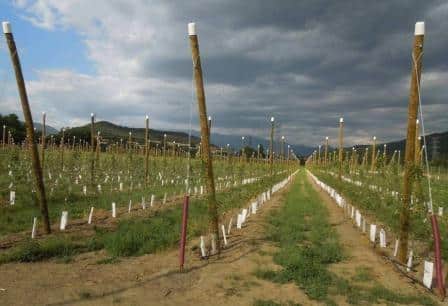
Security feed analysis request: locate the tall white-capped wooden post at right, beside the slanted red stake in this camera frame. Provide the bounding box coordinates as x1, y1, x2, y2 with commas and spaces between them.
398, 22, 425, 263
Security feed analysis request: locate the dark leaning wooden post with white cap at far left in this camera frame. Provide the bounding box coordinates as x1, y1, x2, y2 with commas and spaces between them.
2, 22, 51, 234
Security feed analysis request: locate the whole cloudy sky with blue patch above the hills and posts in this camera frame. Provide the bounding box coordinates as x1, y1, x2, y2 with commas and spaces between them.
0, 0, 448, 145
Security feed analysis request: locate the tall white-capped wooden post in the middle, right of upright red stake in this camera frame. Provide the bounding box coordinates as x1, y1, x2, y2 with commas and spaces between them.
188, 23, 221, 253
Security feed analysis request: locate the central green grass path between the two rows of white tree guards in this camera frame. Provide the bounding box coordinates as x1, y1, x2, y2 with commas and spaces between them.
255, 172, 435, 305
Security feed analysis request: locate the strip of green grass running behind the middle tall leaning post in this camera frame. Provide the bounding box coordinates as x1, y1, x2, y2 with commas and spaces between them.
0, 171, 286, 263
